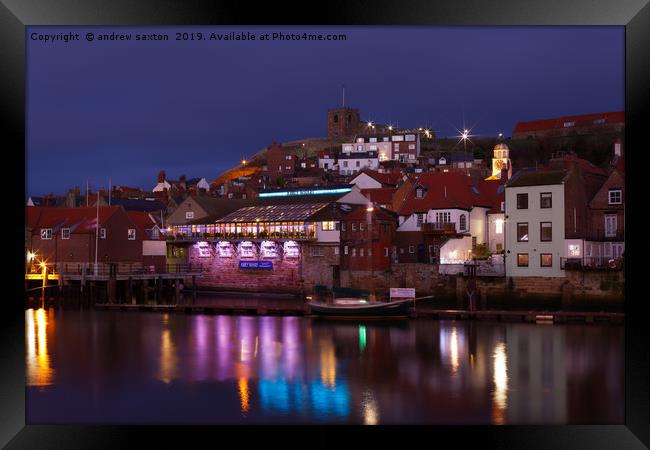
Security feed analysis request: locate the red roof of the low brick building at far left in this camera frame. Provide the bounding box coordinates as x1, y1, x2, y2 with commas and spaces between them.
25, 206, 121, 233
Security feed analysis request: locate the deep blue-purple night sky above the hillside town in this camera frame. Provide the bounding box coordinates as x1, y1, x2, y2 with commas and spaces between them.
26, 26, 624, 195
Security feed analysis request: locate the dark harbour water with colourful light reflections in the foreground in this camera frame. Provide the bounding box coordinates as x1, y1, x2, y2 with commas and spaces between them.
25, 308, 625, 425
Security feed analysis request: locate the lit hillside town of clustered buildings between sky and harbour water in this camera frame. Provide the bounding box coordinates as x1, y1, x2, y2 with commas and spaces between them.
25, 107, 625, 306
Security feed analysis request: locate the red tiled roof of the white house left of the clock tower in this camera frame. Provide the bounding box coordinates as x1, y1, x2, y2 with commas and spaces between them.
399, 172, 500, 216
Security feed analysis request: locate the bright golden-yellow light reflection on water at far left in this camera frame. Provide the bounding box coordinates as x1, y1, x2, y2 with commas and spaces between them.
25, 308, 54, 386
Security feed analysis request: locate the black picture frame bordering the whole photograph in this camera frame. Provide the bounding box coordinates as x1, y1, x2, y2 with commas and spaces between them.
0, 0, 650, 449
